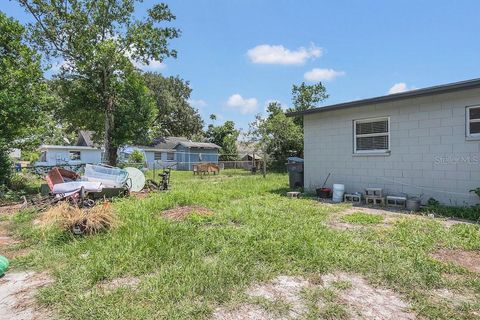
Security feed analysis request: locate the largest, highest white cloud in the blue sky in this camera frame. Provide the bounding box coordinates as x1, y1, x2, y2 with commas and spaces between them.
247, 44, 322, 64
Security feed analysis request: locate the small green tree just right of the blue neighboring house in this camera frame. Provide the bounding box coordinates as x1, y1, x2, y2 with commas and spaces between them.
205, 121, 240, 161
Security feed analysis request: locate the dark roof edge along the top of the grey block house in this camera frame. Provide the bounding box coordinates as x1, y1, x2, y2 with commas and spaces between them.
287, 78, 480, 117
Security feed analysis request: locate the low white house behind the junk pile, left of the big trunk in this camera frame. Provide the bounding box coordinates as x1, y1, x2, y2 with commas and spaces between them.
35, 145, 102, 166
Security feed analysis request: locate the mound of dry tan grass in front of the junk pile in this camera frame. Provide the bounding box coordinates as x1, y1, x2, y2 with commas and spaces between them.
41, 202, 118, 234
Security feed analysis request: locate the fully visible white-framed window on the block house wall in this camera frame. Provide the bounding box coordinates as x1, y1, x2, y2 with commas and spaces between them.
353, 117, 390, 153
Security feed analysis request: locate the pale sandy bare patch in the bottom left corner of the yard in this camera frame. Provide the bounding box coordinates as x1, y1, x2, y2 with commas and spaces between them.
0, 272, 53, 320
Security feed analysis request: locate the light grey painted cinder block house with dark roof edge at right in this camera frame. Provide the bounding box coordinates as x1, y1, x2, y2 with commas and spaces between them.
288, 79, 480, 205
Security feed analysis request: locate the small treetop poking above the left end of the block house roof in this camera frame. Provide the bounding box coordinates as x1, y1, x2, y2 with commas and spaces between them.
287, 82, 328, 128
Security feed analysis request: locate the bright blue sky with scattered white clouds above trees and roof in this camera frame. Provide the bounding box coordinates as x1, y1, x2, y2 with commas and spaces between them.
0, 0, 480, 129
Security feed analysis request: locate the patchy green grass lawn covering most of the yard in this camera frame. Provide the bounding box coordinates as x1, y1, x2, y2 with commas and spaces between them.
6, 172, 480, 319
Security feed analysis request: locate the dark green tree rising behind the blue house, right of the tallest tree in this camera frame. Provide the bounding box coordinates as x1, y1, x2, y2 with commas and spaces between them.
143, 72, 203, 138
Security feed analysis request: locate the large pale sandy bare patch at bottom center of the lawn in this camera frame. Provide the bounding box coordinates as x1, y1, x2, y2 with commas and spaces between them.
213, 272, 416, 320
